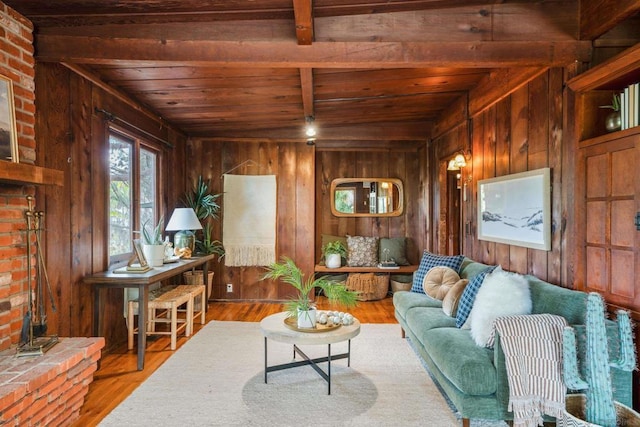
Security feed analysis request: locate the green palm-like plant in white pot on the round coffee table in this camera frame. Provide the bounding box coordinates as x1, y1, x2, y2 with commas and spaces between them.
262, 257, 358, 328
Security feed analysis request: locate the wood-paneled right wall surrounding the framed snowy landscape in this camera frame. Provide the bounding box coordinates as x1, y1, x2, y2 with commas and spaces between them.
429, 69, 575, 287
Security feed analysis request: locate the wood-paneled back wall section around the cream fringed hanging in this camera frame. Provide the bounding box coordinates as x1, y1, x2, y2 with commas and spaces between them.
186, 139, 315, 300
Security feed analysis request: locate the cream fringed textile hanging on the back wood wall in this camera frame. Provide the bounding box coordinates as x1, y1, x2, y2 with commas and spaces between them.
222, 174, 277, 267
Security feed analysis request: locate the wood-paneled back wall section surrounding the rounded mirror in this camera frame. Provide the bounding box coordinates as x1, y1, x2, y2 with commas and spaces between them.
315, 150, 426, 263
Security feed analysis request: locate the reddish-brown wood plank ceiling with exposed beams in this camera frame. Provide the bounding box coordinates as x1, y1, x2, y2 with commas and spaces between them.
3, 0, 639, 145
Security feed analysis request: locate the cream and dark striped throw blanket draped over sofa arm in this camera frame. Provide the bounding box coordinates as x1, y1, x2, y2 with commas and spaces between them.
489, 314, 567, 427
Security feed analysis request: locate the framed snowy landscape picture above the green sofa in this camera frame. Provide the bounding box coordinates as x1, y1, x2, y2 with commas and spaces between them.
478, 168, 551, 251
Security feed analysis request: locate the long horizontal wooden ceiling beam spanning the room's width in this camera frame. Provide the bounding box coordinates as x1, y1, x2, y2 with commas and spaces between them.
36, 35, 591, 68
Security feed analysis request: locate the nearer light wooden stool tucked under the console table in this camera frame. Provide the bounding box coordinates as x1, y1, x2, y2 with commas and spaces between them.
127, 287, 194, 350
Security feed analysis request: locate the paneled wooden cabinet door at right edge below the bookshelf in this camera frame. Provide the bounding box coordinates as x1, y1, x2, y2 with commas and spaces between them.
577, 139, 640, 311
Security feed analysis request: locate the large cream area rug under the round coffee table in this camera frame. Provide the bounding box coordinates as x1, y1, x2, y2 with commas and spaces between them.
100, 321, 504, 427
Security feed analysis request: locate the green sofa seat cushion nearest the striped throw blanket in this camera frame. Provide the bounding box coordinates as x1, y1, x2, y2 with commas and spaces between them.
417, 326, 497, 396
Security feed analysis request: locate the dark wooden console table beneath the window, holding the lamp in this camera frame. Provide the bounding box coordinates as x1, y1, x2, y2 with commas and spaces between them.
83, 254, 215, 371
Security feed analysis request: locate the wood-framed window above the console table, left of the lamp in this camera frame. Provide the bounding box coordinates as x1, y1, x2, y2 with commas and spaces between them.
109, 129, 160, 263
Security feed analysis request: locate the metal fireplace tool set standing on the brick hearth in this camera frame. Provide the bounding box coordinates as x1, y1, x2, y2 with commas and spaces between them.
18, 196, 58, 356
